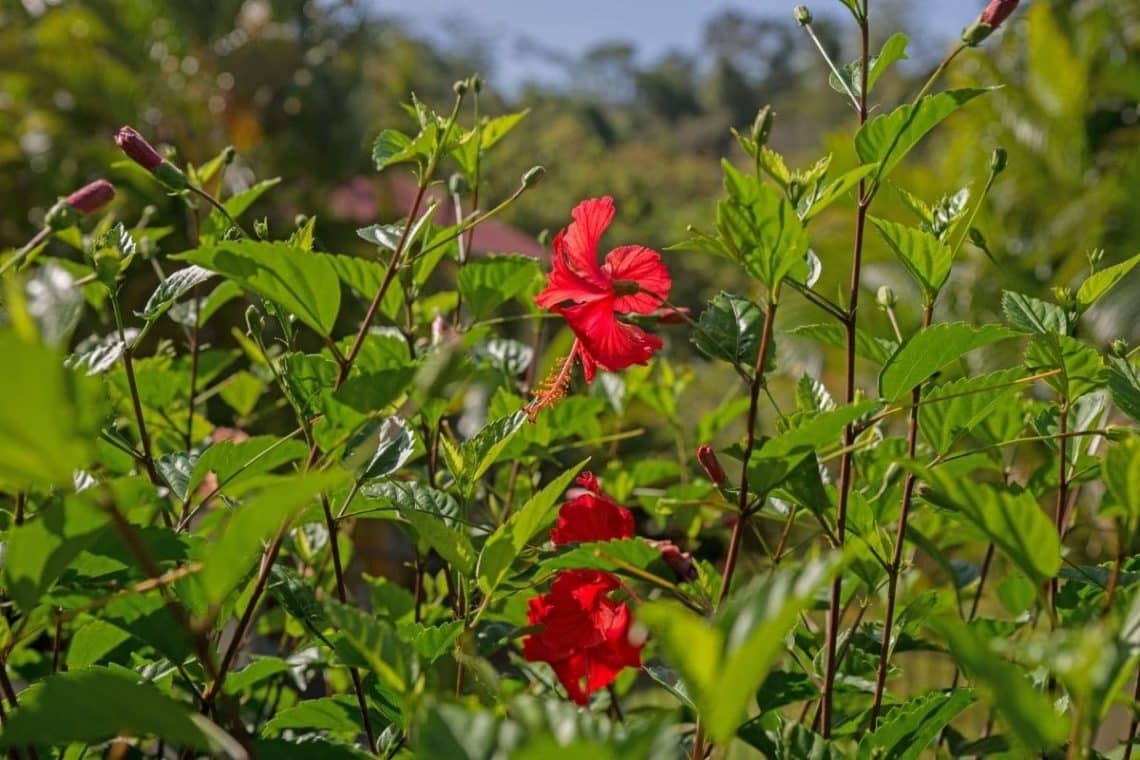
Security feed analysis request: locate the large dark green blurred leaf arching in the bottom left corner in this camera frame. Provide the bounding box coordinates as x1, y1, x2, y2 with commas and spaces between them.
0, 668, 218, 750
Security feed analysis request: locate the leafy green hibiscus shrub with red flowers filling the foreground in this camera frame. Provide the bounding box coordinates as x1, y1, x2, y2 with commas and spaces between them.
0, 0, 1140, 760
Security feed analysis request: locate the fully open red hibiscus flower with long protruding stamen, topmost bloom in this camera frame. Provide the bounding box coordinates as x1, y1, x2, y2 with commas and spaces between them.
530, 196, 673, 418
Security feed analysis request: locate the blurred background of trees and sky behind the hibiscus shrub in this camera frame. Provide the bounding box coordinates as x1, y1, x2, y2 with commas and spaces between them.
0, 0, 1140, 342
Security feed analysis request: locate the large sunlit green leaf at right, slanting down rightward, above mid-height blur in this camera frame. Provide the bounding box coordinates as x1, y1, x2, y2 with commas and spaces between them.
904, 463, 1061, 588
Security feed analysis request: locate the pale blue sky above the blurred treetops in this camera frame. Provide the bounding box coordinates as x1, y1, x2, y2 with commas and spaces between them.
372, 0, 983, 89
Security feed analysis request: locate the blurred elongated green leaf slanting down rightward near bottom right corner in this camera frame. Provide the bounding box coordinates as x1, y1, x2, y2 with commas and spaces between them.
931, 619, 1069, 753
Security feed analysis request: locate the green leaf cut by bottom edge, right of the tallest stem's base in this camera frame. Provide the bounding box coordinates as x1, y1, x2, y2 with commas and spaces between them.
858, 688, 974, 760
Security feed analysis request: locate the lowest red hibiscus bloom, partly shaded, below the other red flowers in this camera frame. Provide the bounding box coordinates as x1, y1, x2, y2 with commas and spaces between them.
522, 570, 641, 704
